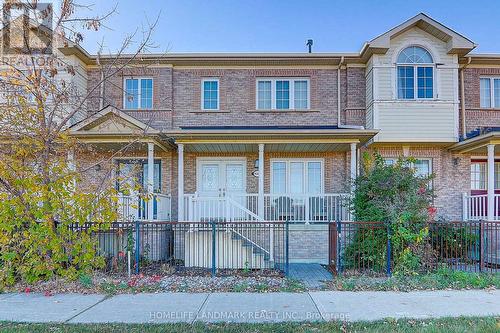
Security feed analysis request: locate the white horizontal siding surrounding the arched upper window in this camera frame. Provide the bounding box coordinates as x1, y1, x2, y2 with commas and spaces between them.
367, 28, 458, 142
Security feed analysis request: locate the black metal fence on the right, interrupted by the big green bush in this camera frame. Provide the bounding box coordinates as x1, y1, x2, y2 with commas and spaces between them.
329, 221, 500, 275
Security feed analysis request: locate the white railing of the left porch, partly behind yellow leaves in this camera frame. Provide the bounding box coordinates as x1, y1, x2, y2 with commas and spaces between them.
118, 193, 172, 221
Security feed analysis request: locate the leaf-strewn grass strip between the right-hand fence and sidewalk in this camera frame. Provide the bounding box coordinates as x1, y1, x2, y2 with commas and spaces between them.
328, 268, 500, 291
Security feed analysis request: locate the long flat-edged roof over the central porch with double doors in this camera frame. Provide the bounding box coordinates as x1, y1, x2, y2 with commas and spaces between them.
168, 126, 378, 153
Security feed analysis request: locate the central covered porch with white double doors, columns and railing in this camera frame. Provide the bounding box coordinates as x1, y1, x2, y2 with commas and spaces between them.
173, 126, 376, 224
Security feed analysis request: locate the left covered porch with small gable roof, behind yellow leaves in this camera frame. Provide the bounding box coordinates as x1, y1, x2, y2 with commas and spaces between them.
68, 106, 175, 222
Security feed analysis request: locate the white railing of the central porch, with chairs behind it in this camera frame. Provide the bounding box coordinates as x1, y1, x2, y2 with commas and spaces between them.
184, 193, 351, 223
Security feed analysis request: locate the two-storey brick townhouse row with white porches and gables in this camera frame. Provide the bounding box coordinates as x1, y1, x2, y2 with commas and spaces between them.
62, 14, 500, 261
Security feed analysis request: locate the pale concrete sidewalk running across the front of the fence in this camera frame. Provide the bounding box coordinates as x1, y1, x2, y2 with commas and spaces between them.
0, 290, 500, 323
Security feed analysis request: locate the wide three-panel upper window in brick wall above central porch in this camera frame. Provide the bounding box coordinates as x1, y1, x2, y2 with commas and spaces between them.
256, 78, 310, 110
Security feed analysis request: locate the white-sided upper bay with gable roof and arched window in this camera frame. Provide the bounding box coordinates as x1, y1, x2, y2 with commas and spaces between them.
361, 13, 476, 143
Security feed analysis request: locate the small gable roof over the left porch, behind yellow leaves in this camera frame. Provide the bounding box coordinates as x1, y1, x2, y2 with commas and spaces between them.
70, 105, 160, 136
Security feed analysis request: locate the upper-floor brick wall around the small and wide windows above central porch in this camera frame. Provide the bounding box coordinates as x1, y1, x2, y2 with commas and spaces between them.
173, 69, 337, 128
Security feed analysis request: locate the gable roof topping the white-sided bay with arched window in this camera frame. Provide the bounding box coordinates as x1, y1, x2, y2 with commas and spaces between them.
361, 13, 477, 56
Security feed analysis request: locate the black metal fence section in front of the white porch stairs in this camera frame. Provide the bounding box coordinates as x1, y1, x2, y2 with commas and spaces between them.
72, 221, 288, 275
